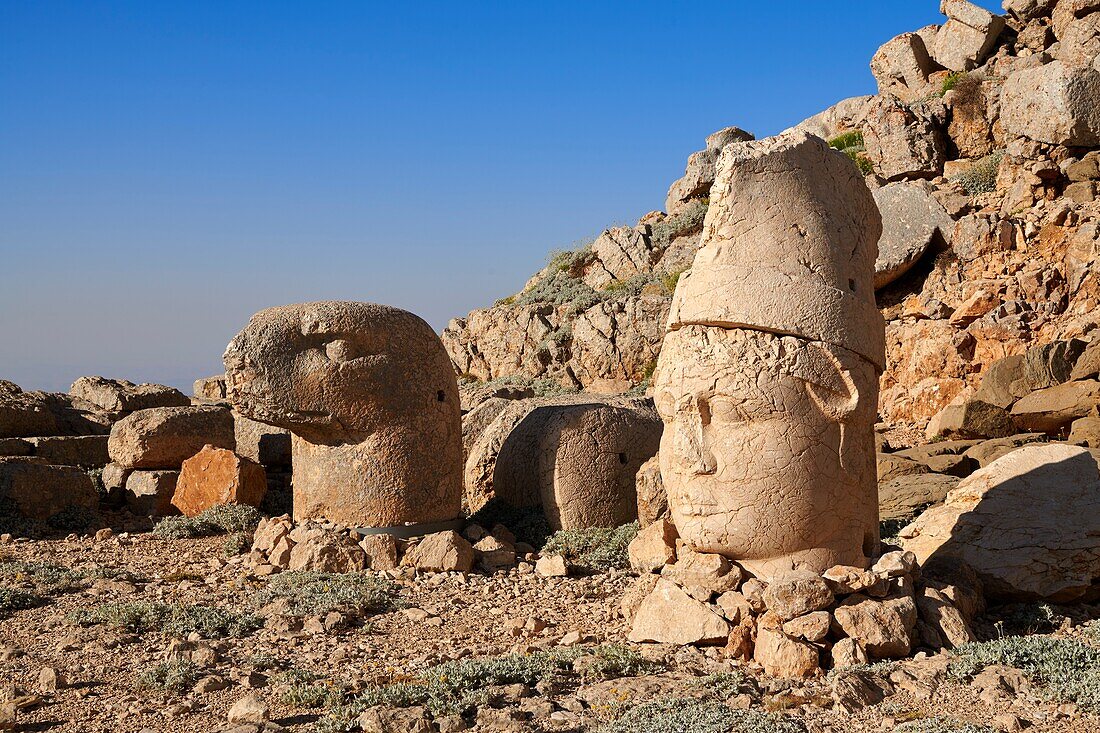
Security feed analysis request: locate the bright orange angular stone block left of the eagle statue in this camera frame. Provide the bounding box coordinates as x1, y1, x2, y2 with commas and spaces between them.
172, 446, 267, 516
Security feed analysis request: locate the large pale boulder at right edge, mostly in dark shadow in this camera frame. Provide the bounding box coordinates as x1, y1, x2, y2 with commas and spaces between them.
902, 444, 1100, 602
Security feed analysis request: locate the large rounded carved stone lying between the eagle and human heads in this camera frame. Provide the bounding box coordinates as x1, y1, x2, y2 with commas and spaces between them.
459, 395, 661, 528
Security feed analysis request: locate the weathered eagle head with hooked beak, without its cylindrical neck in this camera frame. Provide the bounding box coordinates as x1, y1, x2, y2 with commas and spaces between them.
224, 302, 459, 442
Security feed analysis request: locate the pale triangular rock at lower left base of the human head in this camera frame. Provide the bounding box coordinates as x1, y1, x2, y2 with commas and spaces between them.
627, 578, 730, 645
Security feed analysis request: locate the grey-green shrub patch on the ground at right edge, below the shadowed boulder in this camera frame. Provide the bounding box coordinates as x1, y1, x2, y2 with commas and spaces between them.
949, 636, 1100, 711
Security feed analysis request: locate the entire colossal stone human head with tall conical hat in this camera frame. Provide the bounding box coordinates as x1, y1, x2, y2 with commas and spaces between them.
653, 133, 884, 579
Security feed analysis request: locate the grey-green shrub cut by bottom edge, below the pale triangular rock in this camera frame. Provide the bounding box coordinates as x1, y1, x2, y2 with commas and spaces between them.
597, 698, 806, 733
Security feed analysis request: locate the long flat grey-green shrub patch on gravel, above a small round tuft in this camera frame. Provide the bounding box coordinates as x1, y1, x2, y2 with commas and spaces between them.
69, 601, 263, 638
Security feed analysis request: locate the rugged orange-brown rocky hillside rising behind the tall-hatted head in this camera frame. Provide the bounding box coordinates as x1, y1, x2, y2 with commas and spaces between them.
442, 0, 1100, 427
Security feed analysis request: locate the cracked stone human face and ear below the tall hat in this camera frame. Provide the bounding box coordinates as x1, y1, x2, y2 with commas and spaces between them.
653, 326, 878, 578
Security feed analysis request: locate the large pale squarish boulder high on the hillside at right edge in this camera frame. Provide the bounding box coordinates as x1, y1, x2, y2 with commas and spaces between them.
1000, 62, 1100, 147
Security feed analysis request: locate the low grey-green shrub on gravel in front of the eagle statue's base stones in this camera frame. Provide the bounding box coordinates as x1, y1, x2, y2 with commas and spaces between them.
255, 570, 398, 616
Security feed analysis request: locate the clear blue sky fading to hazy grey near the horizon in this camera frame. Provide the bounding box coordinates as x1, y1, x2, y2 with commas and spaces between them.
0, 0, 998, 390
